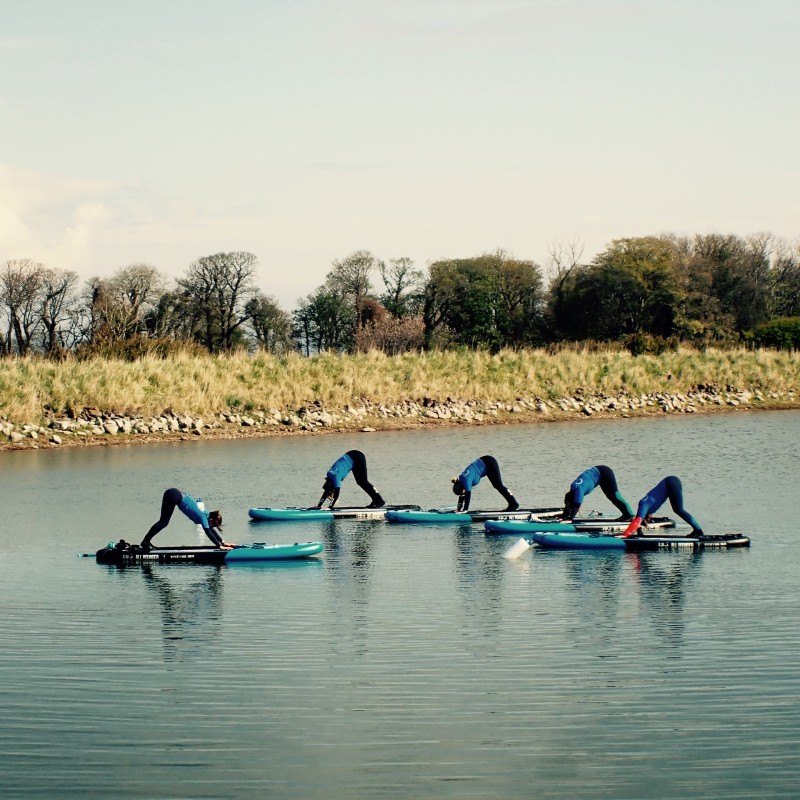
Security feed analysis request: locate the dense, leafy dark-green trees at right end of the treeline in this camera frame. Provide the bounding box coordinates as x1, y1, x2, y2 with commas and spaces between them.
548, 234, 800, 342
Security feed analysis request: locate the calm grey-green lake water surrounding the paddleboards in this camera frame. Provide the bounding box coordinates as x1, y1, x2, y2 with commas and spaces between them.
0, 412, 800, 800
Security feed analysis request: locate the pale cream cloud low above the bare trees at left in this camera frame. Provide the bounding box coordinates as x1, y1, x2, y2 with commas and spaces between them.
0, 164, 276, 278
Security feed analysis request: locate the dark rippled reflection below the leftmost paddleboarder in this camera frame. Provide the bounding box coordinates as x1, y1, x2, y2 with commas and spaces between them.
139, 564, 223, 663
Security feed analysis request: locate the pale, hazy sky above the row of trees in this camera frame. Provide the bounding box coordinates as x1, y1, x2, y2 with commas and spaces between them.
0, 0, 800, 309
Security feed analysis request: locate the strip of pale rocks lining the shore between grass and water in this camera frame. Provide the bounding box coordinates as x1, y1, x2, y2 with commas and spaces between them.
0, 386, 800, 450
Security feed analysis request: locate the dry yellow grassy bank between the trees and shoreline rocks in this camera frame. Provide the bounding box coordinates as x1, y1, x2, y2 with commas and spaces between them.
0, 350, 800, 422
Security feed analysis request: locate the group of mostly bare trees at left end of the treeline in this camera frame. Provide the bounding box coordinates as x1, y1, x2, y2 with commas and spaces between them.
0, 252, 294, 357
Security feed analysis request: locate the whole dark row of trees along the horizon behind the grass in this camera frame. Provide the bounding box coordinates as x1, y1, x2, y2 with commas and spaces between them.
0, 234, 800, 358
